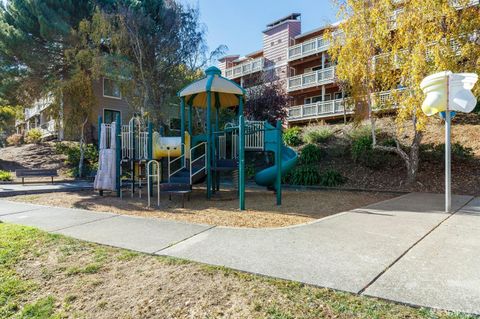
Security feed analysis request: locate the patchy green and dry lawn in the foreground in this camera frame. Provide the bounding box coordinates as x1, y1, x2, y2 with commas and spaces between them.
0, 223, 474, 319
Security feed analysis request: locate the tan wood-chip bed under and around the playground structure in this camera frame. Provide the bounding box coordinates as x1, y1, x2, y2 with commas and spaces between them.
10, 189, 395, 228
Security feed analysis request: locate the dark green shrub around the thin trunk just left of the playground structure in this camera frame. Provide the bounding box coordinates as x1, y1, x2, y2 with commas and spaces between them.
55, 143, 98, 176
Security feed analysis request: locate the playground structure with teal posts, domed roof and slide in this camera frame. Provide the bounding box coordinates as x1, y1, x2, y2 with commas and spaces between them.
93, 67, 298, 210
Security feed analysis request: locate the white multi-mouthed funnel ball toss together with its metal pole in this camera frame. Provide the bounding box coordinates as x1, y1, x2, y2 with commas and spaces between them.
420, 71, 478, 213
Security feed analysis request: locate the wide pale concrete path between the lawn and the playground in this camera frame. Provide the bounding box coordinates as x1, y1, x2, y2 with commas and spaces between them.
0, 193, 480, 314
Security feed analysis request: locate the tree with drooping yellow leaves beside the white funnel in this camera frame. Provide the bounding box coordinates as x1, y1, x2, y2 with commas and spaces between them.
330, 0, 480, 183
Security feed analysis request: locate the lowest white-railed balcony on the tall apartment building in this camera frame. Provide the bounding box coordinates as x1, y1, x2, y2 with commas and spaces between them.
288, 99, 353, 122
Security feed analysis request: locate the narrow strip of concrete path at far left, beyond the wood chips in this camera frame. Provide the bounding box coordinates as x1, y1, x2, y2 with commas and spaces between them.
0, 181, 93, 197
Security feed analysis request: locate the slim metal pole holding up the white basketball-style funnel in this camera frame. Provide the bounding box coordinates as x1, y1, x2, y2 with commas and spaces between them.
445, 75, 452, 213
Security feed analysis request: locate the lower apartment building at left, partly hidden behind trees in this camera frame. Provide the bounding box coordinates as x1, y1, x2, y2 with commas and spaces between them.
15, 78, 132, 140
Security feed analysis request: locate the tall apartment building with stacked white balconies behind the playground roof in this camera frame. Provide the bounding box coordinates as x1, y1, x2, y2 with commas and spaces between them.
219, 13, 351, 124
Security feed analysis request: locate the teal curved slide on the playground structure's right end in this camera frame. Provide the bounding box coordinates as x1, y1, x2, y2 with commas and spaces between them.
255, 124, 298, 187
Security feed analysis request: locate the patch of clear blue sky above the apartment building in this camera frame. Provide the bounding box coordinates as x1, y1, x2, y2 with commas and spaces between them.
181, 0, 337, 55
